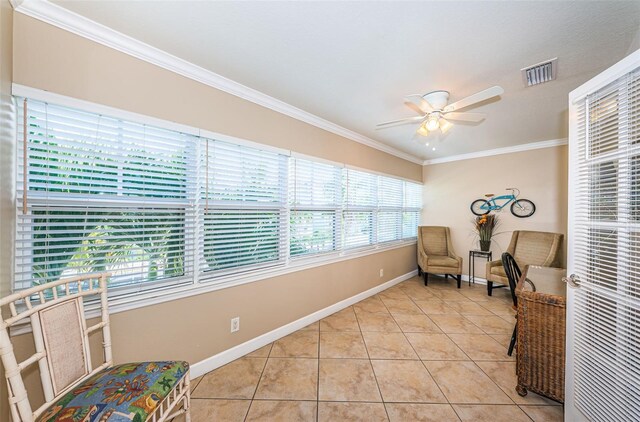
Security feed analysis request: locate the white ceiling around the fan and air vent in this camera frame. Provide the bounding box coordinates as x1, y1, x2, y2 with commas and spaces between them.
55, 0, 640, 159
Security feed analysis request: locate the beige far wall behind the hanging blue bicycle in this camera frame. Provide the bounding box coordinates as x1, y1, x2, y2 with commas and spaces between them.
422, 146, 568, 278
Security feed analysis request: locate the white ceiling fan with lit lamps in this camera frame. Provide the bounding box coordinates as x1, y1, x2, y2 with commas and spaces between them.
376, 86, 504, 136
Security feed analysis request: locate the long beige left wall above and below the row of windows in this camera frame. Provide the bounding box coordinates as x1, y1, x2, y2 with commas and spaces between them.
0, 9, 422, 421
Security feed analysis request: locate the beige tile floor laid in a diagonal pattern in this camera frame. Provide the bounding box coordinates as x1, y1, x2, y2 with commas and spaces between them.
179, 277, 563, 422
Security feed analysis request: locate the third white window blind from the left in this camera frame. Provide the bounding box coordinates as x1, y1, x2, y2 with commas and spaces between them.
289, 158, 342, 257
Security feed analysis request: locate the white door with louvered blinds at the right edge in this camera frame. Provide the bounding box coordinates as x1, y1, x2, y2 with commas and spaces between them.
565, 50, 640, 422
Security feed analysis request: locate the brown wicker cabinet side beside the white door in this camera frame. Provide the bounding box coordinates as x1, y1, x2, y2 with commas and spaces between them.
516, 271, 567, 403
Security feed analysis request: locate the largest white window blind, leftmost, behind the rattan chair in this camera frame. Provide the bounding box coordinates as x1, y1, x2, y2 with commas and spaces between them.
15, 99, 195, 289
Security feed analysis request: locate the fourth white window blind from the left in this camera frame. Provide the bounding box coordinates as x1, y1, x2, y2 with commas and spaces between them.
342, 169, 378, 249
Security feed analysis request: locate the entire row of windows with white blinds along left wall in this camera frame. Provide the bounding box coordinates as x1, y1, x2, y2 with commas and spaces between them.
14, 95, 421, 295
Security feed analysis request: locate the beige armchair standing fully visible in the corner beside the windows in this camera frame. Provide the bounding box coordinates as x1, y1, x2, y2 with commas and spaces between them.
418, 226, 462, 288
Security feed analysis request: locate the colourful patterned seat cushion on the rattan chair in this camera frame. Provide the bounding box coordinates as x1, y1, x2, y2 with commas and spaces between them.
38, 361, 189, 422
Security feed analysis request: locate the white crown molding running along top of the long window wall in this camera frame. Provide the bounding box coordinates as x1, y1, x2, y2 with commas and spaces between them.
11, 0, 422, 164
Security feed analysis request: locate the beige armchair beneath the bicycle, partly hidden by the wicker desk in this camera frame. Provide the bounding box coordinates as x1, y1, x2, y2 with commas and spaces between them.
486, 230, 564, 296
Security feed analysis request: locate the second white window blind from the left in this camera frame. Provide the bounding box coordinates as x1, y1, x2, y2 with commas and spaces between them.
200, 139, 287, 275
